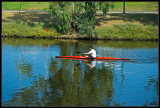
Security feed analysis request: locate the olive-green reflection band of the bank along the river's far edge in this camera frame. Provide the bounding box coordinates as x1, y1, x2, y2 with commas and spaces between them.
2, 38, 158, 50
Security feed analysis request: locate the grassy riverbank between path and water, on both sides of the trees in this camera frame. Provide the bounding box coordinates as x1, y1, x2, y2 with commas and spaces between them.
2, 12, 158, 41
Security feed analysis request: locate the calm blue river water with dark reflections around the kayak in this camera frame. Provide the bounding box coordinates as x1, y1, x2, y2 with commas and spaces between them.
2, 39, 159, 106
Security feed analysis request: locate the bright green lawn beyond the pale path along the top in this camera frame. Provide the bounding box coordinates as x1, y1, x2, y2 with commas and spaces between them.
2, 2, 158, 11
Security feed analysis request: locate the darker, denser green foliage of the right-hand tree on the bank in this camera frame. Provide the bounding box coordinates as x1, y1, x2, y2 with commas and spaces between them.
73, 2, 96, 36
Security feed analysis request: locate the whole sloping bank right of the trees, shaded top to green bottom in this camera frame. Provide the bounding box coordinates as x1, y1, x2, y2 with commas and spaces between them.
96, 14, 158, 40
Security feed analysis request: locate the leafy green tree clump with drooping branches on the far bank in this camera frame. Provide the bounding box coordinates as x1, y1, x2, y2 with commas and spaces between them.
49, 2, 114, 36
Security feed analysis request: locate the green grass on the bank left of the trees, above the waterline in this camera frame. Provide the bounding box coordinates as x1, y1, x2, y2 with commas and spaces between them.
2, 21, 60, 37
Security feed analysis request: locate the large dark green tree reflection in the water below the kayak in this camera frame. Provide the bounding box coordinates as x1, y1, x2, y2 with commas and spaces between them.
5, 57, 114, 106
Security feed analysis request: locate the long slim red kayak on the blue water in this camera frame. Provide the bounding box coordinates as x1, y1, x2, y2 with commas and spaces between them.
55, 56, 130, 60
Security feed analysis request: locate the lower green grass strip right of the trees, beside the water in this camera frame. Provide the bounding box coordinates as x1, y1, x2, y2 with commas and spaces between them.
96, 23, 158, 39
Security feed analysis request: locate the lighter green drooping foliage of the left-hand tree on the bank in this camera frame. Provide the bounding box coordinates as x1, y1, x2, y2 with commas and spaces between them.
49, 2, 72, 34
